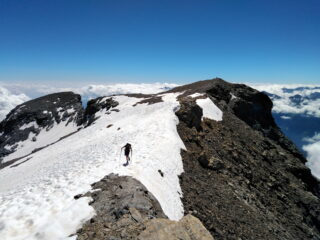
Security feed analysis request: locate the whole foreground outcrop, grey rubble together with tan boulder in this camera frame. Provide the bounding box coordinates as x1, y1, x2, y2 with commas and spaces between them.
77, 174, 212, 240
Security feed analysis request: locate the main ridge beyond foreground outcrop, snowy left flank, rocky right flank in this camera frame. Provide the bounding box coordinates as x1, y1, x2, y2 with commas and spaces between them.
0, 79, 320, 240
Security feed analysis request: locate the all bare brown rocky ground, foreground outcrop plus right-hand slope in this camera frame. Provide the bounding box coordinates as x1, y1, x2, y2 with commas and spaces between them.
77, 79, 320, 240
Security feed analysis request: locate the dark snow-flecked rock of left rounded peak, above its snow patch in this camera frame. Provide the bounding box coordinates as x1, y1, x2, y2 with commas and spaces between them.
0, 92, 83, 159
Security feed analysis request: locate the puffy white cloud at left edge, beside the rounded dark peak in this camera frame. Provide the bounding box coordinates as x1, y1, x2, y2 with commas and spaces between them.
0, 86, 30, 121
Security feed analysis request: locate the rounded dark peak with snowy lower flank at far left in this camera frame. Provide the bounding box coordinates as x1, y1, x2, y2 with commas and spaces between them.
0, 92, 83, 164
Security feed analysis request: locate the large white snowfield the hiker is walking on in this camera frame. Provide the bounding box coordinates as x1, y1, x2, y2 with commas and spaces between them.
0, 93, 185, 240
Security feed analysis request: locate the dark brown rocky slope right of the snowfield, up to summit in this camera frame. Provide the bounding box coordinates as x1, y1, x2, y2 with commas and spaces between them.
175, 79, 320, 240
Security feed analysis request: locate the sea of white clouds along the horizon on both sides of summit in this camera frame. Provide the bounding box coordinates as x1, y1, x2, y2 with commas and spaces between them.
0, 83, 320, 179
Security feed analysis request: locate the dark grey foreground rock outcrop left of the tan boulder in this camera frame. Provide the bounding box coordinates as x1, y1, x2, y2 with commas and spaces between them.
77, 174, 162, 240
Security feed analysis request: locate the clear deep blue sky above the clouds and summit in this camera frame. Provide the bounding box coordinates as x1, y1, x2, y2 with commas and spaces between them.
0, 0, 320, 83
